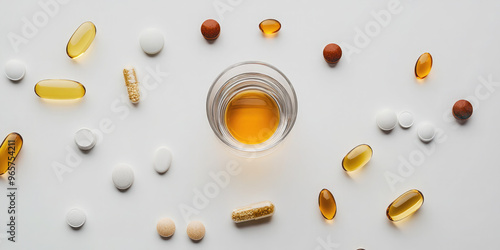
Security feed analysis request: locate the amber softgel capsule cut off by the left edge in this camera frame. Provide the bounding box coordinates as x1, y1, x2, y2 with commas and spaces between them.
0, 132, 23, 175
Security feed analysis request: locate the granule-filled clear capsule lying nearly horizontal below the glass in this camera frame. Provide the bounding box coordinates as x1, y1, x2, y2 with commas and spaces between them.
231, 201, 274, 223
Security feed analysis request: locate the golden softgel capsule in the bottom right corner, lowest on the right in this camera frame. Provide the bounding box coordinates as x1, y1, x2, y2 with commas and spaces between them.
386, 189, 424, 221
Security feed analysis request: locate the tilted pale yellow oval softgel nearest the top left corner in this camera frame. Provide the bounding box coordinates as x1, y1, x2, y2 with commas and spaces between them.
66, 22, 97, 58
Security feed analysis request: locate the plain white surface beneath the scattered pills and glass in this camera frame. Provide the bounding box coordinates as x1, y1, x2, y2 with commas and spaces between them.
0, 0, 500, 249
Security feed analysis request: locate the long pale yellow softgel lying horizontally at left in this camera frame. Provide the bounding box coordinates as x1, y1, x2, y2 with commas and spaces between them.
35, 79, 86, 100
